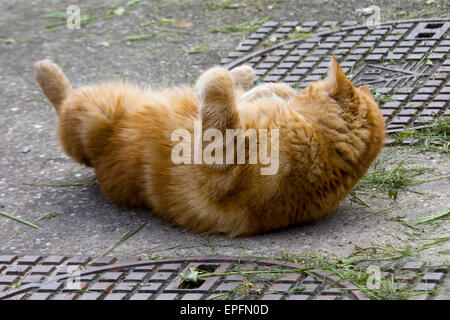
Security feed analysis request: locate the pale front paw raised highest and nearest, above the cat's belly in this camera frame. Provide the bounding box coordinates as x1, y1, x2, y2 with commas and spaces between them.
195, 67, 233, 101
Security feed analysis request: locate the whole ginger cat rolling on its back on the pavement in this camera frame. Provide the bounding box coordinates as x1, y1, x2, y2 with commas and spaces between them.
35, 56, 384, 236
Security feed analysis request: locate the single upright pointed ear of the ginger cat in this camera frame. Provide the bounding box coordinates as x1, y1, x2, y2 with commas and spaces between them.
325, 55, 355, 99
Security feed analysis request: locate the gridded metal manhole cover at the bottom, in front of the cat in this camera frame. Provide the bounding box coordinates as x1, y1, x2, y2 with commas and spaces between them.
0, 255, 448, 300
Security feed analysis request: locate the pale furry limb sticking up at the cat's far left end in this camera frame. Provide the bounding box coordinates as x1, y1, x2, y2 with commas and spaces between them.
34, 59, 72, 113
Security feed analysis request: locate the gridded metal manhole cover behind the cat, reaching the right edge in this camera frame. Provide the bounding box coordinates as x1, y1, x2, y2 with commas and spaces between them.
221, 19, 450, 133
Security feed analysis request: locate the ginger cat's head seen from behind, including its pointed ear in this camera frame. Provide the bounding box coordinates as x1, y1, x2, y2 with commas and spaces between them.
296, 56, 385, 170
